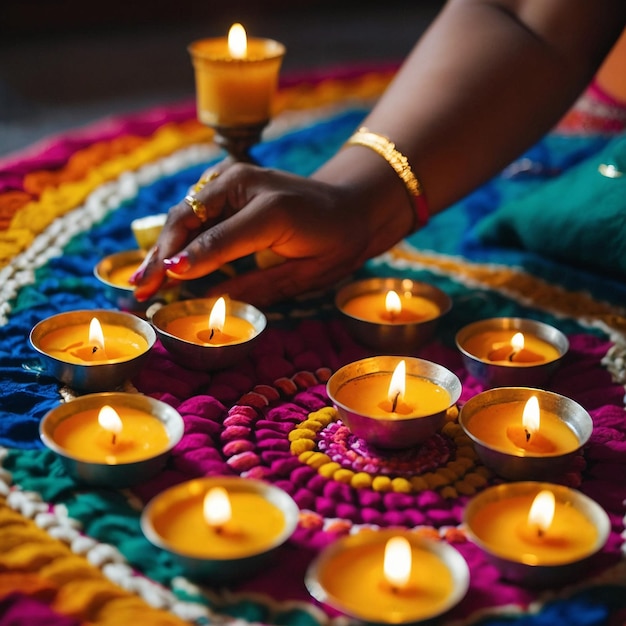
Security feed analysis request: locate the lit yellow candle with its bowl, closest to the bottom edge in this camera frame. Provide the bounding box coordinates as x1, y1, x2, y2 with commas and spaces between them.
305, 530, 469, 624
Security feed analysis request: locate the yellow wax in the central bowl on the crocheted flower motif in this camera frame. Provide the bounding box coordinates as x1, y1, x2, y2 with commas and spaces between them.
335, 372, 451, 419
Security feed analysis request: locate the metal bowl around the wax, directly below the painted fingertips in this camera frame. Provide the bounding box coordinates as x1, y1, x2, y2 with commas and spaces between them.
151, 298, 267, 370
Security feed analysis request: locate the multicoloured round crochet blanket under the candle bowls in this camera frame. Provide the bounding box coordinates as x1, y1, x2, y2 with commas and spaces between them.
0, 67, 626, 626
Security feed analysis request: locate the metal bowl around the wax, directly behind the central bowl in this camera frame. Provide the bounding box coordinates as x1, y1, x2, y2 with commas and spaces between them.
335, 278, 452, 354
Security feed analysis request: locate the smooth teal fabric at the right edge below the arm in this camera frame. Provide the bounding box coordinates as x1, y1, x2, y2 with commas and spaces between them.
475, 135, 626, 279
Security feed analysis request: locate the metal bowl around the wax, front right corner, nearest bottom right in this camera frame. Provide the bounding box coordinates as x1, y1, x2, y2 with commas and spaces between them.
463, 481, 611, 589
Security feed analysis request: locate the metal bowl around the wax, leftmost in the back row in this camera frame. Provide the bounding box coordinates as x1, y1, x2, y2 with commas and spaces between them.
29, 309, 156, 391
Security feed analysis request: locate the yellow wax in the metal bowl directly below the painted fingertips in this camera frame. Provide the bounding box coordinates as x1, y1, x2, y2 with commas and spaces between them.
165, 315, 255, 346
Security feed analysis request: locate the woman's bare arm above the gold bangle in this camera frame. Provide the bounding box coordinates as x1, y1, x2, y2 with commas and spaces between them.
316, 0, 626, 213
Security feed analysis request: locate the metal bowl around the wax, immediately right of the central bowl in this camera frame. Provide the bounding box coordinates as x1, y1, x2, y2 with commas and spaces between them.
459, 387, 593, 480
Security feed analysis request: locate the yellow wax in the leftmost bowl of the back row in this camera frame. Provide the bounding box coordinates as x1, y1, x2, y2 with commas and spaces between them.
41, 323, 148, 364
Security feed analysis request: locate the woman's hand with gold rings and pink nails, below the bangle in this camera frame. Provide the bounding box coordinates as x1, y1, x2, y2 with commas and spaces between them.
133, 162, 388, 305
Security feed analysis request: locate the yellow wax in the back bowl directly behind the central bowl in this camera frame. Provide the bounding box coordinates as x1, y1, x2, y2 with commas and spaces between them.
342, 293, 441, 324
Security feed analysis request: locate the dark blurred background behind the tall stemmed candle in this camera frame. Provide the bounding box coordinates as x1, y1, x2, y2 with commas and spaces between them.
0, 0, 444, 157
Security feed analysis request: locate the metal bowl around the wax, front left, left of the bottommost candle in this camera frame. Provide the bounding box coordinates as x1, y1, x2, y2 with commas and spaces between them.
141, 476, 299, 584
